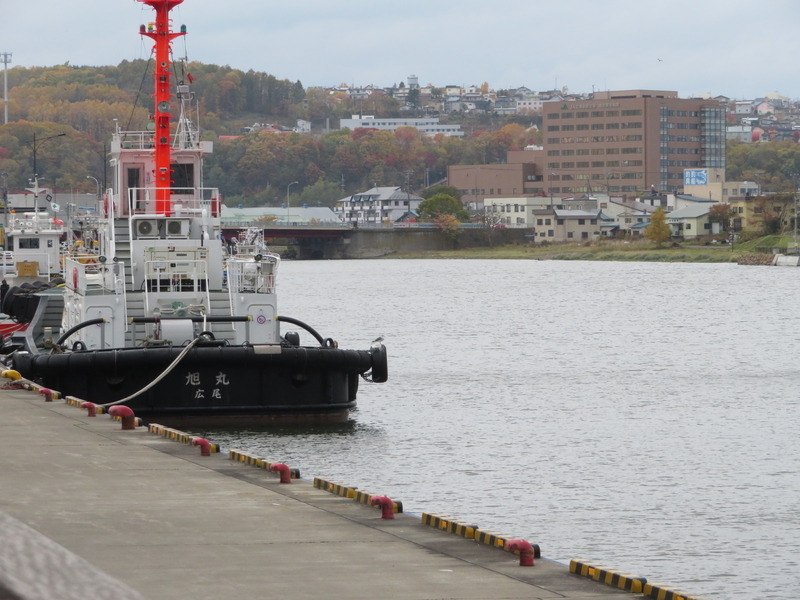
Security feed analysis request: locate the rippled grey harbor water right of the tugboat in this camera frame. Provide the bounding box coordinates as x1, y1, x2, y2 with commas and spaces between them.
195, 260, 800, 599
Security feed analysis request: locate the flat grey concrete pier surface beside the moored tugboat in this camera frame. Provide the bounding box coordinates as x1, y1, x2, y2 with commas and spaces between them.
0, 380, 642, 600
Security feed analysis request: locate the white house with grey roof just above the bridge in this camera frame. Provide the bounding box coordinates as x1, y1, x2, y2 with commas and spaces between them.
334, 187, 423, 225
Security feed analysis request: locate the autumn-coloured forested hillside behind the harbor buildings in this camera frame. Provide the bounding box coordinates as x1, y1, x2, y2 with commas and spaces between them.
0, 60, 800, 205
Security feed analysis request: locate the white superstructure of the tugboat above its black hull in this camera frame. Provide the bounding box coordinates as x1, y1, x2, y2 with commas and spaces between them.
62, 86, 280, 349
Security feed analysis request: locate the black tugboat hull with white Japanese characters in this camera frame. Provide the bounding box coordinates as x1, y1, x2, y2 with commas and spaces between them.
14, 345, 386, 426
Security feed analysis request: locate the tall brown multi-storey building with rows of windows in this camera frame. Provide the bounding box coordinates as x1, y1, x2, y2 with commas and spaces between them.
537, 90, 725, 196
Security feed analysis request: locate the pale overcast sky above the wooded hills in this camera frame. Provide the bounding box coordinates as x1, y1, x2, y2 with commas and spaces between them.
6, 0, 800, 99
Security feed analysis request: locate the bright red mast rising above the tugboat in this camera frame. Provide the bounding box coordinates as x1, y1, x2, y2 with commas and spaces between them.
138, 0, 186, 215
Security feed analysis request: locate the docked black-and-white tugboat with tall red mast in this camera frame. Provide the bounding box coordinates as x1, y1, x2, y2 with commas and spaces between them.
10, 0, 388, 426
